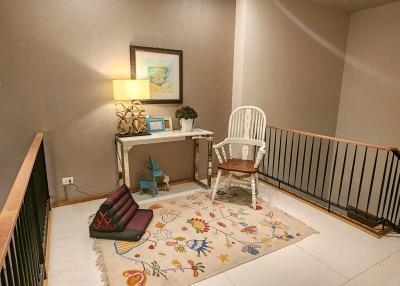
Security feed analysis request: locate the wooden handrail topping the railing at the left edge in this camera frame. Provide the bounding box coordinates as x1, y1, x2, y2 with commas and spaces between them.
0, 133, 43, 266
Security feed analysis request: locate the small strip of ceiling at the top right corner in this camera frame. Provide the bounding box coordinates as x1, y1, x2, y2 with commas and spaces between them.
312, 0, 397, 12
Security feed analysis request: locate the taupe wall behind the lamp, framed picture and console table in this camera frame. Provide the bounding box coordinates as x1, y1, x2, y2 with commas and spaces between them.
0, 0, 235, 203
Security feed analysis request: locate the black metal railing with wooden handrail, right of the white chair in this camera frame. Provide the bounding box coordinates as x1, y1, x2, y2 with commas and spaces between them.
260, 126, 400, 232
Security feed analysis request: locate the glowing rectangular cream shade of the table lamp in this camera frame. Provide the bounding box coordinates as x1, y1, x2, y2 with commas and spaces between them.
113, 79, 150, 100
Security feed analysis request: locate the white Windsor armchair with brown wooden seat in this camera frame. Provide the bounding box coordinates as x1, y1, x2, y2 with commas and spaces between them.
211, 106, 267, 209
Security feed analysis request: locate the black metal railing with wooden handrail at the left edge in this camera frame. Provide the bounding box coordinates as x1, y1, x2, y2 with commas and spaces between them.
0, 133, 50, 286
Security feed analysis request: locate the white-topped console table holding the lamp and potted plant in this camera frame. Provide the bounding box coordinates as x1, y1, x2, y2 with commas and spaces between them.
115, 128, 214, 189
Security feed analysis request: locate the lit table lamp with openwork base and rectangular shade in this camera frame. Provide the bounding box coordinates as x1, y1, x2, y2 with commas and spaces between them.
113, 79, 150, 136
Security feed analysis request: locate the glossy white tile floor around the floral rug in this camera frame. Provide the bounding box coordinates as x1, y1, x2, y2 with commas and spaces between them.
49, 183, 400, 286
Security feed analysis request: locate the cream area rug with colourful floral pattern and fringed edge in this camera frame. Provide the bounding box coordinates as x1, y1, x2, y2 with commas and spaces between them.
95, 188, 315, 286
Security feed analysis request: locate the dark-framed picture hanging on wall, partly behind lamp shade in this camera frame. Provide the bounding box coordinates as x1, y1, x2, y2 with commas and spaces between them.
130, 46, 183, 104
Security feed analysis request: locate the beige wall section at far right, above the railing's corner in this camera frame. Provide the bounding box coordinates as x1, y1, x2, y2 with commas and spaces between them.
336, 2, 400, 150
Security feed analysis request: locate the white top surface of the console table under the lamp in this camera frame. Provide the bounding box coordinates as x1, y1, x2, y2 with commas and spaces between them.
118, 128, 214, 146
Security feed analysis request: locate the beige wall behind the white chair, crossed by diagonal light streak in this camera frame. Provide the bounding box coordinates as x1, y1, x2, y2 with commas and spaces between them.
233, 0, 349, 135
